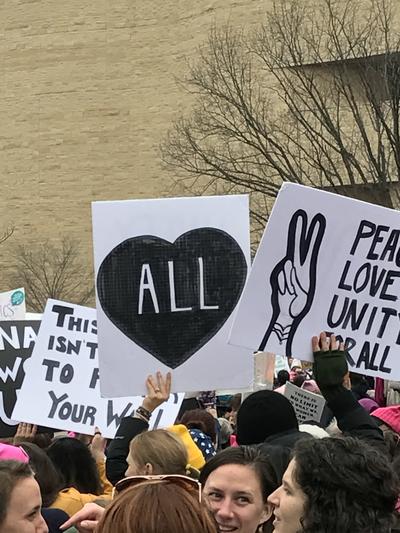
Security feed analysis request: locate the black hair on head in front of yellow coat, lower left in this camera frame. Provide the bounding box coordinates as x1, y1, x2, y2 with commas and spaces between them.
47, 437, 102, 494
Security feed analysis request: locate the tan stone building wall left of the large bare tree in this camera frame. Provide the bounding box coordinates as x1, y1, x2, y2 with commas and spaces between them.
0, 0, 268, 287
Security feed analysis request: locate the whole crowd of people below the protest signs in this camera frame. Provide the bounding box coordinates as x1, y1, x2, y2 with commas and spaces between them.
0, 333, 400, 533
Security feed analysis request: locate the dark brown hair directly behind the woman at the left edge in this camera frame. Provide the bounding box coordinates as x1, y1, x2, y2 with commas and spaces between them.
20, 442, 60, 507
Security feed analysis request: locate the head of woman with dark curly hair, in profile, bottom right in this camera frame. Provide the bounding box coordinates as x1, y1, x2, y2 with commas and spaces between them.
269, 438, 399, 533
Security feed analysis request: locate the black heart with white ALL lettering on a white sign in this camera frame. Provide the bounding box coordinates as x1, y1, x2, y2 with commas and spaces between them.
97, 228, 247, 368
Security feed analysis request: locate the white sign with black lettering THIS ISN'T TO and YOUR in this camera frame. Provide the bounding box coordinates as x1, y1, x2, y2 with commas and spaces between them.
13, 300, 184, 438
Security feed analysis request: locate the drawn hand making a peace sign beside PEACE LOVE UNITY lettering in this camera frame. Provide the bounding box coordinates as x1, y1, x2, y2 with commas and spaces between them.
259, 209, 326, 357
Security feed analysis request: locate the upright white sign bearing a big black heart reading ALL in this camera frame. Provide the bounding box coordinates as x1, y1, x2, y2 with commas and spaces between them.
92, 196, 252, 397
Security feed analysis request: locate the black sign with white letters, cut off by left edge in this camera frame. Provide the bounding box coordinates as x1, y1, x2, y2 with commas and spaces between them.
0, 320, 40, 437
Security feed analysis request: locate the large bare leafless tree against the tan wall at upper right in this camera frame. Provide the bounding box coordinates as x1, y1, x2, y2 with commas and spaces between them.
160, 0, 400, 241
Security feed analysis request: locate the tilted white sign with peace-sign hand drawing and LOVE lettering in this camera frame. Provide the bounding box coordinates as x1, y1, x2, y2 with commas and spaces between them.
230, 184, 400, 380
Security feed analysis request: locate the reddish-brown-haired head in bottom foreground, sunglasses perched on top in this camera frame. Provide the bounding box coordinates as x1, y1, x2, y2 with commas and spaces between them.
96, 480, 217, 533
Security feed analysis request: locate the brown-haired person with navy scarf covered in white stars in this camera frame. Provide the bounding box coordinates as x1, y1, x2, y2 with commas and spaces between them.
180, 409, 218, 461
